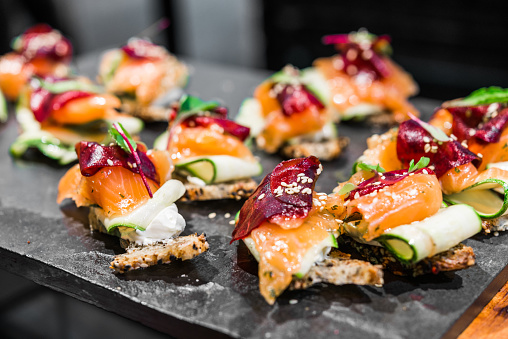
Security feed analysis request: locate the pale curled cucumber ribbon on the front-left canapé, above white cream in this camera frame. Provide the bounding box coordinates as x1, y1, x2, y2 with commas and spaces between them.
96, 180, 185, 233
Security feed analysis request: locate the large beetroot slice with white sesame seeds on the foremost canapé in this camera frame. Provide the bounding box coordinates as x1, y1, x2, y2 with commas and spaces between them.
231, 156, 321, 243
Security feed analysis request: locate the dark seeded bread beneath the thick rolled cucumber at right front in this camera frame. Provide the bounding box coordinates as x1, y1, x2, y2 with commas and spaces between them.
339, 236, 475, 277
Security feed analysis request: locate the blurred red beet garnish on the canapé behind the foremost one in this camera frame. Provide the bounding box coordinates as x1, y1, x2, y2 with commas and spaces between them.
277, 85, 324, 116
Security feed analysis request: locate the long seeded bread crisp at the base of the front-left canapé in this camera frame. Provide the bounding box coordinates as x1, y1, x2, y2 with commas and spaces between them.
88, 206, 209, 273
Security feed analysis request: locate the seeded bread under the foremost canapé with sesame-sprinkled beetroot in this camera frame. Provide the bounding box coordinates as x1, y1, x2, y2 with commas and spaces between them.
289, 250, 384, 290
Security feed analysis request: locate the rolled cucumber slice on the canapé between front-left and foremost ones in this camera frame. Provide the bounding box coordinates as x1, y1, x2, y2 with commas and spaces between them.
175, 155, 263, 184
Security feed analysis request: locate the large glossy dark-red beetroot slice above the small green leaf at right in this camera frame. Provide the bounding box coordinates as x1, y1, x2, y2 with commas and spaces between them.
397, 120, 480, 178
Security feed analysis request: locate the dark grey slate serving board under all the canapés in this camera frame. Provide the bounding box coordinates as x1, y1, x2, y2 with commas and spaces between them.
0, 57, 508, 339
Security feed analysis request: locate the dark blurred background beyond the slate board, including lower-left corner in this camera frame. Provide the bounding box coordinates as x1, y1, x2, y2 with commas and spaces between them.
0, 0, 508, 339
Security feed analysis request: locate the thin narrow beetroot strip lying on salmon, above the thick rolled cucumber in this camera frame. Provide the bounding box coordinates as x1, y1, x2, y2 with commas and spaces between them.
346, 168, 435, 200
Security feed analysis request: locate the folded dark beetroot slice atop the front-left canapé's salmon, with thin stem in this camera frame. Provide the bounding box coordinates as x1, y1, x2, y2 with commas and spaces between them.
76, 141, 159, 183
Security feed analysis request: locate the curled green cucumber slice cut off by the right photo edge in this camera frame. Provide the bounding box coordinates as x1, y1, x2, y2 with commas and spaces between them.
443, 178, 508, 219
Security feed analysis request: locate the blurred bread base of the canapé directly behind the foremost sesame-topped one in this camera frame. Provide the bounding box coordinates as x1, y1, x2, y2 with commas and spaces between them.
280, 137, 349, 161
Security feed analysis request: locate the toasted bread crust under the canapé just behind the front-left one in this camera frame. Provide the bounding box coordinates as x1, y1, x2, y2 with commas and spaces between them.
180, 178, 258, 201
